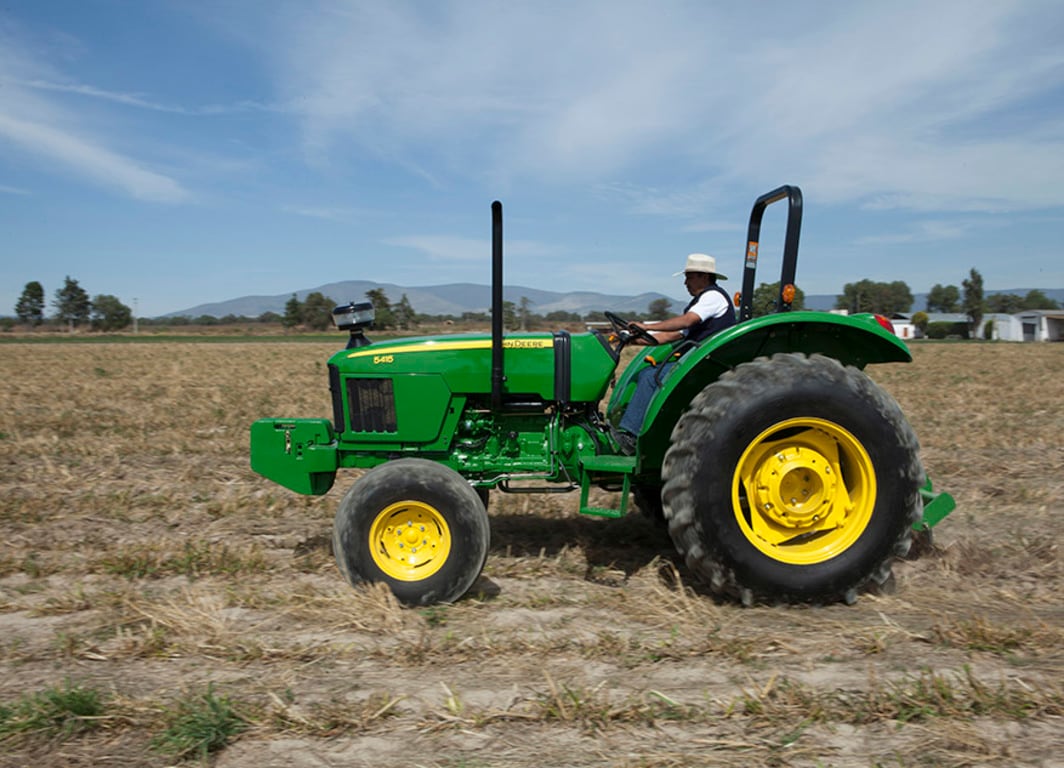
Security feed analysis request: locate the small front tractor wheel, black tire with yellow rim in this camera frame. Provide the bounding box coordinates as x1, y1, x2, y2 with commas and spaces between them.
333, 458, 491, 605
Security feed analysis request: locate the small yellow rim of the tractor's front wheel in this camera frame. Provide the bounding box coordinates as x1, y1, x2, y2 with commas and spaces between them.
369, 501, 451, 582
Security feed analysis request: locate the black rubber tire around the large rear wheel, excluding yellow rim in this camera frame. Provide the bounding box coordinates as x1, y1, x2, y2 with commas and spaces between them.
666, 358, 915, 600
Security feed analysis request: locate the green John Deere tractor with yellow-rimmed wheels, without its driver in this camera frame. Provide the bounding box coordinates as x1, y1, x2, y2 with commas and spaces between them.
251, 186, 953, 605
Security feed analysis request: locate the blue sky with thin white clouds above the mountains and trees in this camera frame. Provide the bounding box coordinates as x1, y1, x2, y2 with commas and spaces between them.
0, 0, 1064, 317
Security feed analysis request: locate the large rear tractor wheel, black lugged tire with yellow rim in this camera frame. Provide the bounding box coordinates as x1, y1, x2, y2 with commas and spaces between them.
662, 354, 924, 604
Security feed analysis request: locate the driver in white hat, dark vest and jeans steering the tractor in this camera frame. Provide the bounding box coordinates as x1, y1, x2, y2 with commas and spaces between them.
614, 253, 735, 455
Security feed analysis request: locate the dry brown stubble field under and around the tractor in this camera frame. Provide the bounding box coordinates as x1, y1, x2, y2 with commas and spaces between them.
0, 343, 1064, 768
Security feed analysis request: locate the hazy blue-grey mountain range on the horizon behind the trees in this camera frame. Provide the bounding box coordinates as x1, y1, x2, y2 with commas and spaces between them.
163, 280, 1064, 317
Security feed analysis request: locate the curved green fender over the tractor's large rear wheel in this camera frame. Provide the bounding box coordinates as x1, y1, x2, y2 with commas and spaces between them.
639, 312, 912, 469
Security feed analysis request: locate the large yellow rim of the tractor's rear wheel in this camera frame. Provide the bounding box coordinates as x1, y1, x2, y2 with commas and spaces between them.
732, 418, 876, 565
